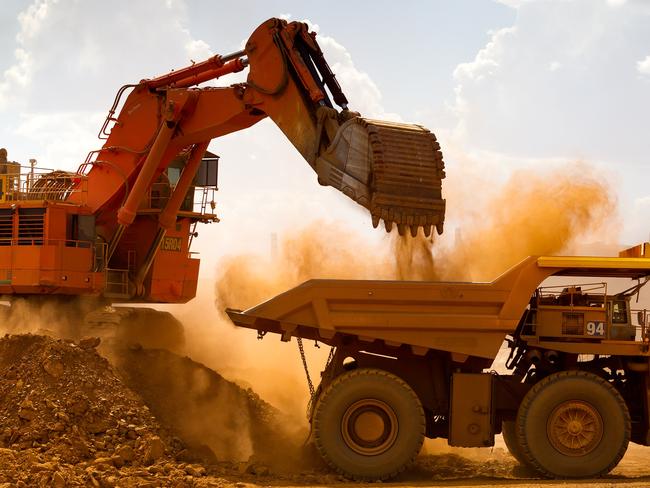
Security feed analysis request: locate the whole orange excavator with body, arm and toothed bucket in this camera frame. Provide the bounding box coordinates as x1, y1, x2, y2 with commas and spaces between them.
0, 19, 445, 344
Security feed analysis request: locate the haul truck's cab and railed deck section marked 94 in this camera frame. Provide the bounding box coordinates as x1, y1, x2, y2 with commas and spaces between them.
521, 283, 637, 342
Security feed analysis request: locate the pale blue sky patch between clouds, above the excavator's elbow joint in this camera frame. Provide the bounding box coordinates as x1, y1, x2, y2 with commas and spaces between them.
188, 0, 516, 119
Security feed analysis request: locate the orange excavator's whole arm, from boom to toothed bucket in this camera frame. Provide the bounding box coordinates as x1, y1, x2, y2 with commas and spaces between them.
69, 19, 445, 252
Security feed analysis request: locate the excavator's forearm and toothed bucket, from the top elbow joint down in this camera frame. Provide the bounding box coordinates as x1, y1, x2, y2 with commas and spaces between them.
246, 19, 445, 235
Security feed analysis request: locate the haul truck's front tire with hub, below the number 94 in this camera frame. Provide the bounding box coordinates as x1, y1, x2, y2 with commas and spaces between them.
517, 371, 631, 478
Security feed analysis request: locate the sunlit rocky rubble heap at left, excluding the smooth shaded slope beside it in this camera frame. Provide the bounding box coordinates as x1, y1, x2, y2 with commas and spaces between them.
0, 334, 223, 486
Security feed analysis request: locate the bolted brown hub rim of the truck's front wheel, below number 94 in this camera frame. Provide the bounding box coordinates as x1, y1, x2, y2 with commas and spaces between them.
546, 400, 603, 457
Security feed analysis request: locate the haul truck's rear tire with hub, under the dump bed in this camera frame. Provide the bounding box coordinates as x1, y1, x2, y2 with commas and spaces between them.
312, 368, 425, 481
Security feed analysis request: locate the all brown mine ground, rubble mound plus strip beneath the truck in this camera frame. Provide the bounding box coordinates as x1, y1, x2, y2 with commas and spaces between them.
0, 334, 650, 488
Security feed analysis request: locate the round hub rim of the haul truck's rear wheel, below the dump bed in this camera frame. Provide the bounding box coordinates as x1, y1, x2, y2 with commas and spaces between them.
341, 398, 398, 456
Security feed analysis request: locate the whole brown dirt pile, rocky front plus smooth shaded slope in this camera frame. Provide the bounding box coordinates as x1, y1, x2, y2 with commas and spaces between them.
0, 334, 322, 488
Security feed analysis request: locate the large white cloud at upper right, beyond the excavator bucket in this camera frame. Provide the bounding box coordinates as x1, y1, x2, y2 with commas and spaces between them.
443, 0, 650, 241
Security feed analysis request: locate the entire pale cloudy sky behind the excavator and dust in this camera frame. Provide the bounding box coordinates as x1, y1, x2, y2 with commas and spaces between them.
0, 0, 650, 270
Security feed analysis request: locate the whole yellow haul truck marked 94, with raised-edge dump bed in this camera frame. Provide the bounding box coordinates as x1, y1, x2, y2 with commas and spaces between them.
228, 243, 650, 480
